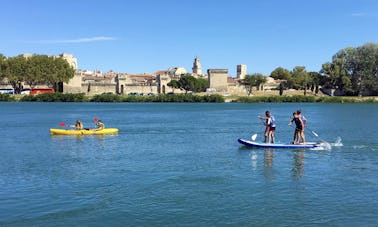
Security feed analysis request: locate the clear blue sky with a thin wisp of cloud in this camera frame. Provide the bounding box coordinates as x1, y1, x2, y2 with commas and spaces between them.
0, 0, 378, 76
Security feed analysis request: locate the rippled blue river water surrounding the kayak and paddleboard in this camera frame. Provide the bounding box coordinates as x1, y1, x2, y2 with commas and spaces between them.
0, 103, 378, 226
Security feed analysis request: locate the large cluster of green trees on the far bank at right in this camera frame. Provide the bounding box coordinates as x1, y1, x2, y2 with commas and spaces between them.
270, 43, 378, 96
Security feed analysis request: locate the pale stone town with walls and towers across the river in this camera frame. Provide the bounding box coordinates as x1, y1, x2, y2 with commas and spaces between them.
0, 53, 281, 96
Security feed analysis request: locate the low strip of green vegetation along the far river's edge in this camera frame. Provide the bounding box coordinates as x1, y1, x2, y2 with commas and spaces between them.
0, 93, 378, 103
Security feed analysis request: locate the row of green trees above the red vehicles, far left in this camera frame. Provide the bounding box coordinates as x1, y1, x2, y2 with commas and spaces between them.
0, 54, 75, 93
